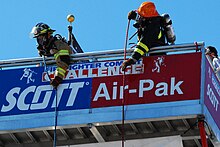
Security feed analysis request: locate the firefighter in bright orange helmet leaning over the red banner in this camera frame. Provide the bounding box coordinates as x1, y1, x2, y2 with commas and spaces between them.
122, 2, 165, 71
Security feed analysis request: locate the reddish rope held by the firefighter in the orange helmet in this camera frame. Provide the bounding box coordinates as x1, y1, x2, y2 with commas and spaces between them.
121, 20, 130, 147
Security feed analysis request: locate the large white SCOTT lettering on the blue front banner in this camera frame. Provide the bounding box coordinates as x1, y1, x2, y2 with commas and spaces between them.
1, 82, 89, 112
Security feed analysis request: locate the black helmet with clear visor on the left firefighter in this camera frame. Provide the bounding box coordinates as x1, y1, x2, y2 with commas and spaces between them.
31, 23, 55, 38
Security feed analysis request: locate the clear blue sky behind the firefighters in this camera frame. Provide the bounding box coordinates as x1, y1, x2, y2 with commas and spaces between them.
0, 0, 220, 60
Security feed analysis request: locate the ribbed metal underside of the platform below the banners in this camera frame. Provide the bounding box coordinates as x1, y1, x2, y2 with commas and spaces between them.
0, 118, 214, 147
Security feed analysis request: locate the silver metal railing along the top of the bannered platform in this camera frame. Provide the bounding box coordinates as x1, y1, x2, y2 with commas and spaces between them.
0, 42, 204, 69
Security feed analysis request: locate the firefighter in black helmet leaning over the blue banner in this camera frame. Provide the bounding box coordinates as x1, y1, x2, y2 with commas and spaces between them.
31, 23, 72, 89
